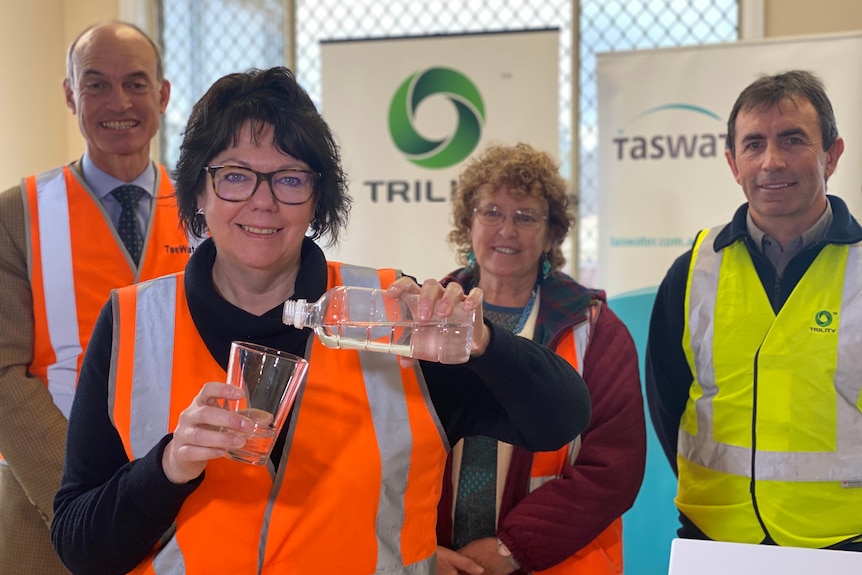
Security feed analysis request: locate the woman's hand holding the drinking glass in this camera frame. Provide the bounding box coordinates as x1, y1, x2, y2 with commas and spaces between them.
162, 381, 254, 484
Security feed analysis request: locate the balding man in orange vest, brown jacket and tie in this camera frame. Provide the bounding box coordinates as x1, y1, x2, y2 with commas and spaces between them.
0, 22, 191, 575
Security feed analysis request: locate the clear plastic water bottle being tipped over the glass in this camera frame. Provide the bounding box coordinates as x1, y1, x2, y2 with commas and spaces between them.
282, 286, 476, 363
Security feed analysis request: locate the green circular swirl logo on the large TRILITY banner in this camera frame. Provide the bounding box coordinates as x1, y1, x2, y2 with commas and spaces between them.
389, 68, 485, 168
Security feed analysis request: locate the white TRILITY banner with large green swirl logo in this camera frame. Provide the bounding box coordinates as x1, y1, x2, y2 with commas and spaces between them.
321, 30, 559, 281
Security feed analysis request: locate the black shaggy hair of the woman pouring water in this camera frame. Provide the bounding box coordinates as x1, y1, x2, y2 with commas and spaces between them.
174, 66, 351, 245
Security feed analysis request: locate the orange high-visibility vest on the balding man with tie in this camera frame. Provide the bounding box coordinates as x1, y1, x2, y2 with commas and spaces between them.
21, 166, 191, 417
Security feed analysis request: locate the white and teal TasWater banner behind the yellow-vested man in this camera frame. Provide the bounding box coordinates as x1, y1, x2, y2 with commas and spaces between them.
596, 34, 862, 575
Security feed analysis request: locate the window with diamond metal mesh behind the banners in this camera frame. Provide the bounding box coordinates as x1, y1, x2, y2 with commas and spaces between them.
158, 0, 739, 285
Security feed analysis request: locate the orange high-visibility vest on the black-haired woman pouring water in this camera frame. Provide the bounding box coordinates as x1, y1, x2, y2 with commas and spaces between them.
109, 263, 448, 575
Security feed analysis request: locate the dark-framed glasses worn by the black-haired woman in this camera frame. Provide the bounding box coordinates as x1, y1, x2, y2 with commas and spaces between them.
204, 166, 320, 206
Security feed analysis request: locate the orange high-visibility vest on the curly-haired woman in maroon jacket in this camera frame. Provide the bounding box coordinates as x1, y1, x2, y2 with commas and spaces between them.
530, 306, 623, 575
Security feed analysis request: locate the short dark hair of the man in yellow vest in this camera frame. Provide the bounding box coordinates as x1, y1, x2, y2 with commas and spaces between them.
726, 70, 838, 154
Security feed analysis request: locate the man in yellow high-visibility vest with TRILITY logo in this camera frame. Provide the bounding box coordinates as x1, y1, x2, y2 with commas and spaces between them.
646, 71, 862, 551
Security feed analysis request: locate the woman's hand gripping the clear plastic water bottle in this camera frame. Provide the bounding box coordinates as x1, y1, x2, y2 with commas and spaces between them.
386, 277, 491, 367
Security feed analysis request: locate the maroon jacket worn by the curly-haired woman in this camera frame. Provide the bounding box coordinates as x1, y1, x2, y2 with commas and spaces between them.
437, 268, 646, 572
